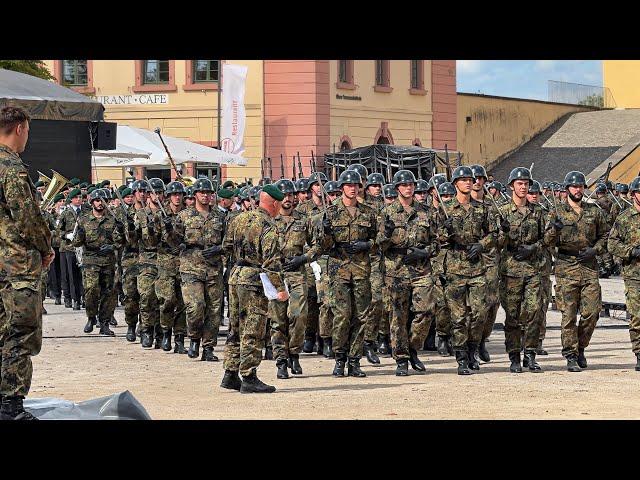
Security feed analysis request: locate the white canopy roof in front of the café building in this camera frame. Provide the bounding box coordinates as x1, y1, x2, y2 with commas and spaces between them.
92, 125, 247, 167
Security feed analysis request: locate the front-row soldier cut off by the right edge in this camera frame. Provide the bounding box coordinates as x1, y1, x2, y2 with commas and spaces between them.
608, 177, 640, 372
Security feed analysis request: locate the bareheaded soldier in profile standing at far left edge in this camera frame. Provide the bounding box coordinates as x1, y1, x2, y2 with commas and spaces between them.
0, 107, 54, 420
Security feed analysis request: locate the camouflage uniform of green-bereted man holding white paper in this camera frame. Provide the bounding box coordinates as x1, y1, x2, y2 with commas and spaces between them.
224, 207, 284, 376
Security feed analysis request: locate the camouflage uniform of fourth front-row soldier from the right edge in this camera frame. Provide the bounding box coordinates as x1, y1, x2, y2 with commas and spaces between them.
439, 198, 497, 351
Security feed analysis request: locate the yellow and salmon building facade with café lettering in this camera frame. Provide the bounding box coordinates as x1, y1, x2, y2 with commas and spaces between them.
46, 60, 457, 184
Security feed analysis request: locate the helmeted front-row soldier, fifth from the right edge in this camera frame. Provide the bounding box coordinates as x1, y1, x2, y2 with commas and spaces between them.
378, 170, 438, 376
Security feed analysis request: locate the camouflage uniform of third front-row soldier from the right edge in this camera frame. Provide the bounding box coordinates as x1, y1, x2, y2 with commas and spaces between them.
498, 202, 546, 353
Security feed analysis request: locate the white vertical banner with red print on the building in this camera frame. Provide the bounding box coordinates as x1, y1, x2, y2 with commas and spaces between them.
220, 63, 247, 155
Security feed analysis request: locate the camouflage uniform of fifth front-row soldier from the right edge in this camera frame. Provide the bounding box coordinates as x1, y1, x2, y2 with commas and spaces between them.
378, 199, 438, 361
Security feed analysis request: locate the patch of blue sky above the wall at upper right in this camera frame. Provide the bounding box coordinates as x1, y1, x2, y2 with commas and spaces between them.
456, 60, 602, 100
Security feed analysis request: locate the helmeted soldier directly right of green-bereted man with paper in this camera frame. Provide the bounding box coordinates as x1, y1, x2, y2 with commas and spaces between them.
269, 179, 320, 379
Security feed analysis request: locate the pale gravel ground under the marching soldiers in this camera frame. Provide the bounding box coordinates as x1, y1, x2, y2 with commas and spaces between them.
31, 279, 640, 419
